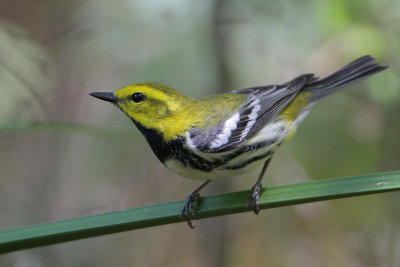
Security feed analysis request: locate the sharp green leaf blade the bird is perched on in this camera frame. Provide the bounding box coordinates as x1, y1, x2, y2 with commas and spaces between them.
0, 171, 400, 253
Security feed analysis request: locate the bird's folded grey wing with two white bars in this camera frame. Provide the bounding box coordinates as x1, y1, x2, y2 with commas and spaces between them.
189, 74, 317, 153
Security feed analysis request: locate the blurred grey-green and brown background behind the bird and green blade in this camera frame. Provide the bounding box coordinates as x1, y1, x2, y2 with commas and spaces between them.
0, 0, 400, 267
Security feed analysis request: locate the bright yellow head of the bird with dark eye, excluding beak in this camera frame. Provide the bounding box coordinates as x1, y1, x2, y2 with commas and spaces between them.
113, 82, 197, 141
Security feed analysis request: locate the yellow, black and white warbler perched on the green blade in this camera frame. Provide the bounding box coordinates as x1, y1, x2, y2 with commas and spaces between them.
90, 55, 387, 227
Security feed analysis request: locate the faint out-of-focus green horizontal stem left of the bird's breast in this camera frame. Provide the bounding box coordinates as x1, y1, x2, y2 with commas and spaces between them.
0, 122, 134, 138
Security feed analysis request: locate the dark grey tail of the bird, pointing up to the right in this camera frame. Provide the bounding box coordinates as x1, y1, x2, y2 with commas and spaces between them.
302, 55, 388, 102
